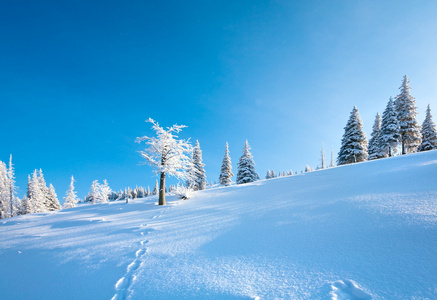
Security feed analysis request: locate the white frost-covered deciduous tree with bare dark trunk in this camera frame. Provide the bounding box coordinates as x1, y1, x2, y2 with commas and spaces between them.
136, 118, 191, 205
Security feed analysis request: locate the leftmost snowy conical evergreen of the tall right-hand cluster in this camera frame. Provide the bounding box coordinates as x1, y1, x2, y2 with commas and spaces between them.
337, 106, 367, 165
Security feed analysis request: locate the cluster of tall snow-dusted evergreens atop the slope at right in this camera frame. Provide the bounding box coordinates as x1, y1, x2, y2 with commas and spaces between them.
337, 75, 437, 165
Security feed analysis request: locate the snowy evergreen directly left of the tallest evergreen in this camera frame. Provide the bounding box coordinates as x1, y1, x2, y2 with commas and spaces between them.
375, 97, 400, 158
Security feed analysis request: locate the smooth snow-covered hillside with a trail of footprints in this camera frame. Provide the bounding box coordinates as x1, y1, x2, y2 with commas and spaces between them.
0, 151, 437, 299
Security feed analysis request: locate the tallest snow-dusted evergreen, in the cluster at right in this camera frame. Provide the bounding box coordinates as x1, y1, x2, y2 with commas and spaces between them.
395, 75, 421, 154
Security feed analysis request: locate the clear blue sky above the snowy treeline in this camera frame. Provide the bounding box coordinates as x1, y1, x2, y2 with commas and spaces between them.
0, 0, 437, 198
